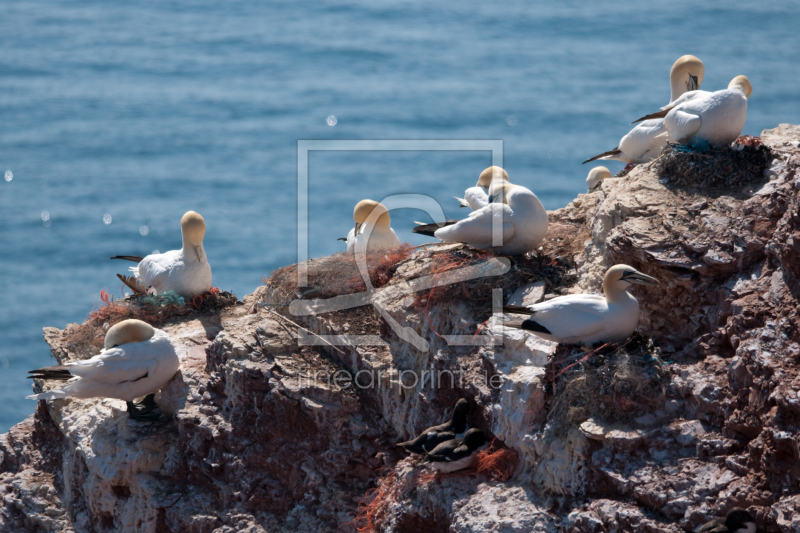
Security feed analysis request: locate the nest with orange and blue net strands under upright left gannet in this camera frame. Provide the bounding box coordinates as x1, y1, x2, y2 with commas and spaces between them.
67, 287, 238, 355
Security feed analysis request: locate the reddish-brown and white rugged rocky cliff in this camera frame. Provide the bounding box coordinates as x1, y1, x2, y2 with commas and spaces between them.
0, 125, 800, 532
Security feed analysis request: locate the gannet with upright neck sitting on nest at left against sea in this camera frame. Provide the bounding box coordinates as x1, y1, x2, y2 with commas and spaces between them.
111, 211, 211, 299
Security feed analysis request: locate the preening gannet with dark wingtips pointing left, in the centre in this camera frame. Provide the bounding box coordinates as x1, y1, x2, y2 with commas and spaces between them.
412, 182, 548, 255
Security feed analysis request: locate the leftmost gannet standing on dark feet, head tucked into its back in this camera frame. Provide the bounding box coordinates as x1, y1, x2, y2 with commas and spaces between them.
27, 320, 180, 421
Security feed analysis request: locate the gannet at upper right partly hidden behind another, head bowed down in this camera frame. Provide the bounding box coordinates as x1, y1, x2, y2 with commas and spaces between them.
584, 55, 705, 164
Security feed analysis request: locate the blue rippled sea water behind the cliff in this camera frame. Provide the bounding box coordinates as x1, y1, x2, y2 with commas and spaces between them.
0, 0, 800, 432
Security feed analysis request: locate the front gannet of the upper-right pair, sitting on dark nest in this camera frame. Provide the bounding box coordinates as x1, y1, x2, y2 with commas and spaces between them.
637, 76, 753, 146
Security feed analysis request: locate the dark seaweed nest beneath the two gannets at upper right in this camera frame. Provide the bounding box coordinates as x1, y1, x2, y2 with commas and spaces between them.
655, 138, 772, 194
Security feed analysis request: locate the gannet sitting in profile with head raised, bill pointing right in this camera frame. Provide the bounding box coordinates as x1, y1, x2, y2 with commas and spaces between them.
503, 265, 658, 346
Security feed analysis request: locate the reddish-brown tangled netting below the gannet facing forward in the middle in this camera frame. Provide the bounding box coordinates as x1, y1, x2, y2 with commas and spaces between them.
262, 244, 414, 305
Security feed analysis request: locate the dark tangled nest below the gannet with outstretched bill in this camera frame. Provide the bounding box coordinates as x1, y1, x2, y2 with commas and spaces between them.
545, 332, 668, 434
